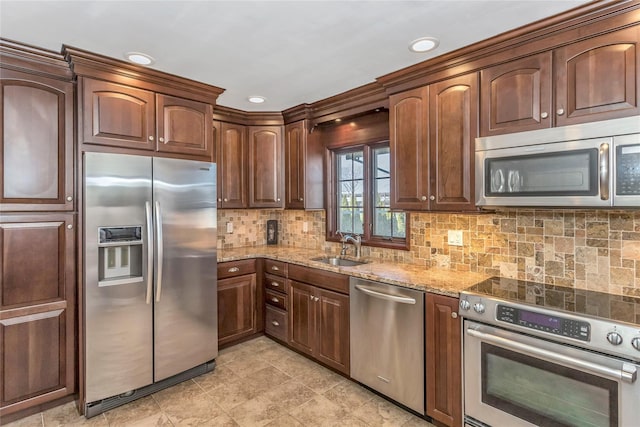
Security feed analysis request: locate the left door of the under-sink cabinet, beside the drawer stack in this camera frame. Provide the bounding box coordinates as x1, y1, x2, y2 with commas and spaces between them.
289, 280, 315, 354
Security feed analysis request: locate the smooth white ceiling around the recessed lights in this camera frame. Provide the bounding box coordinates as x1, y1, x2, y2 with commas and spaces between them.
0, 0, 588, 111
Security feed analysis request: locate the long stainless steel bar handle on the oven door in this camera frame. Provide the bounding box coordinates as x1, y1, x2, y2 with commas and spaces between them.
467, 328, 637, 384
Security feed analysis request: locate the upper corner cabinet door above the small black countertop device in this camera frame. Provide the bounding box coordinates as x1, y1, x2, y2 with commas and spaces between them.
249, 126, 284, 208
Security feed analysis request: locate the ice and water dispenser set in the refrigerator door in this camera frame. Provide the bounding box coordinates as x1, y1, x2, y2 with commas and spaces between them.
98, 226, 143, 286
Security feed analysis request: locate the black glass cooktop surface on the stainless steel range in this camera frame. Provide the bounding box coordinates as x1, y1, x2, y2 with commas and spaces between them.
463, 277, 640, 325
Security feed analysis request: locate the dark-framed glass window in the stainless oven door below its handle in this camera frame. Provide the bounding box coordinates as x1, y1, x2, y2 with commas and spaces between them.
482, 343, 618, 427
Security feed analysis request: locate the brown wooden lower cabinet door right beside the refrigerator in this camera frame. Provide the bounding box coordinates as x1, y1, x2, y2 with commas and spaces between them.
218, 273, 257, 345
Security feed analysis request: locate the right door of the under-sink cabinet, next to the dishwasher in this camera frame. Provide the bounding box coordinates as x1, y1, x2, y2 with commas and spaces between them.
314, 288, 350, 374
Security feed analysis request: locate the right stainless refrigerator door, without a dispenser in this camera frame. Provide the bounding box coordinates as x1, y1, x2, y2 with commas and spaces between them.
153, 158, 218, 381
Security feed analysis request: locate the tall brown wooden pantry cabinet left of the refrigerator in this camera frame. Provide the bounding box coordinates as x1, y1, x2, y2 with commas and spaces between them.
0, 40, 76, 419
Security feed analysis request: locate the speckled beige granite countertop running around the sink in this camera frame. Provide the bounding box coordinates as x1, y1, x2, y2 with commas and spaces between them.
218, 245, 489, 298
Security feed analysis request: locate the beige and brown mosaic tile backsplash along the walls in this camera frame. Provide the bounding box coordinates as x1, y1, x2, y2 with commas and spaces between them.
218, 209, 640, 296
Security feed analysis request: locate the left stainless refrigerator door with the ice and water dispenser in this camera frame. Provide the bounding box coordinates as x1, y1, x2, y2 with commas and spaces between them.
84, 153, 153, 402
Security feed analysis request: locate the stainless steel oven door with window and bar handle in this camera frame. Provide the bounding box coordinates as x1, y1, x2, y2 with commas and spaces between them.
464, 320, 640, 427
